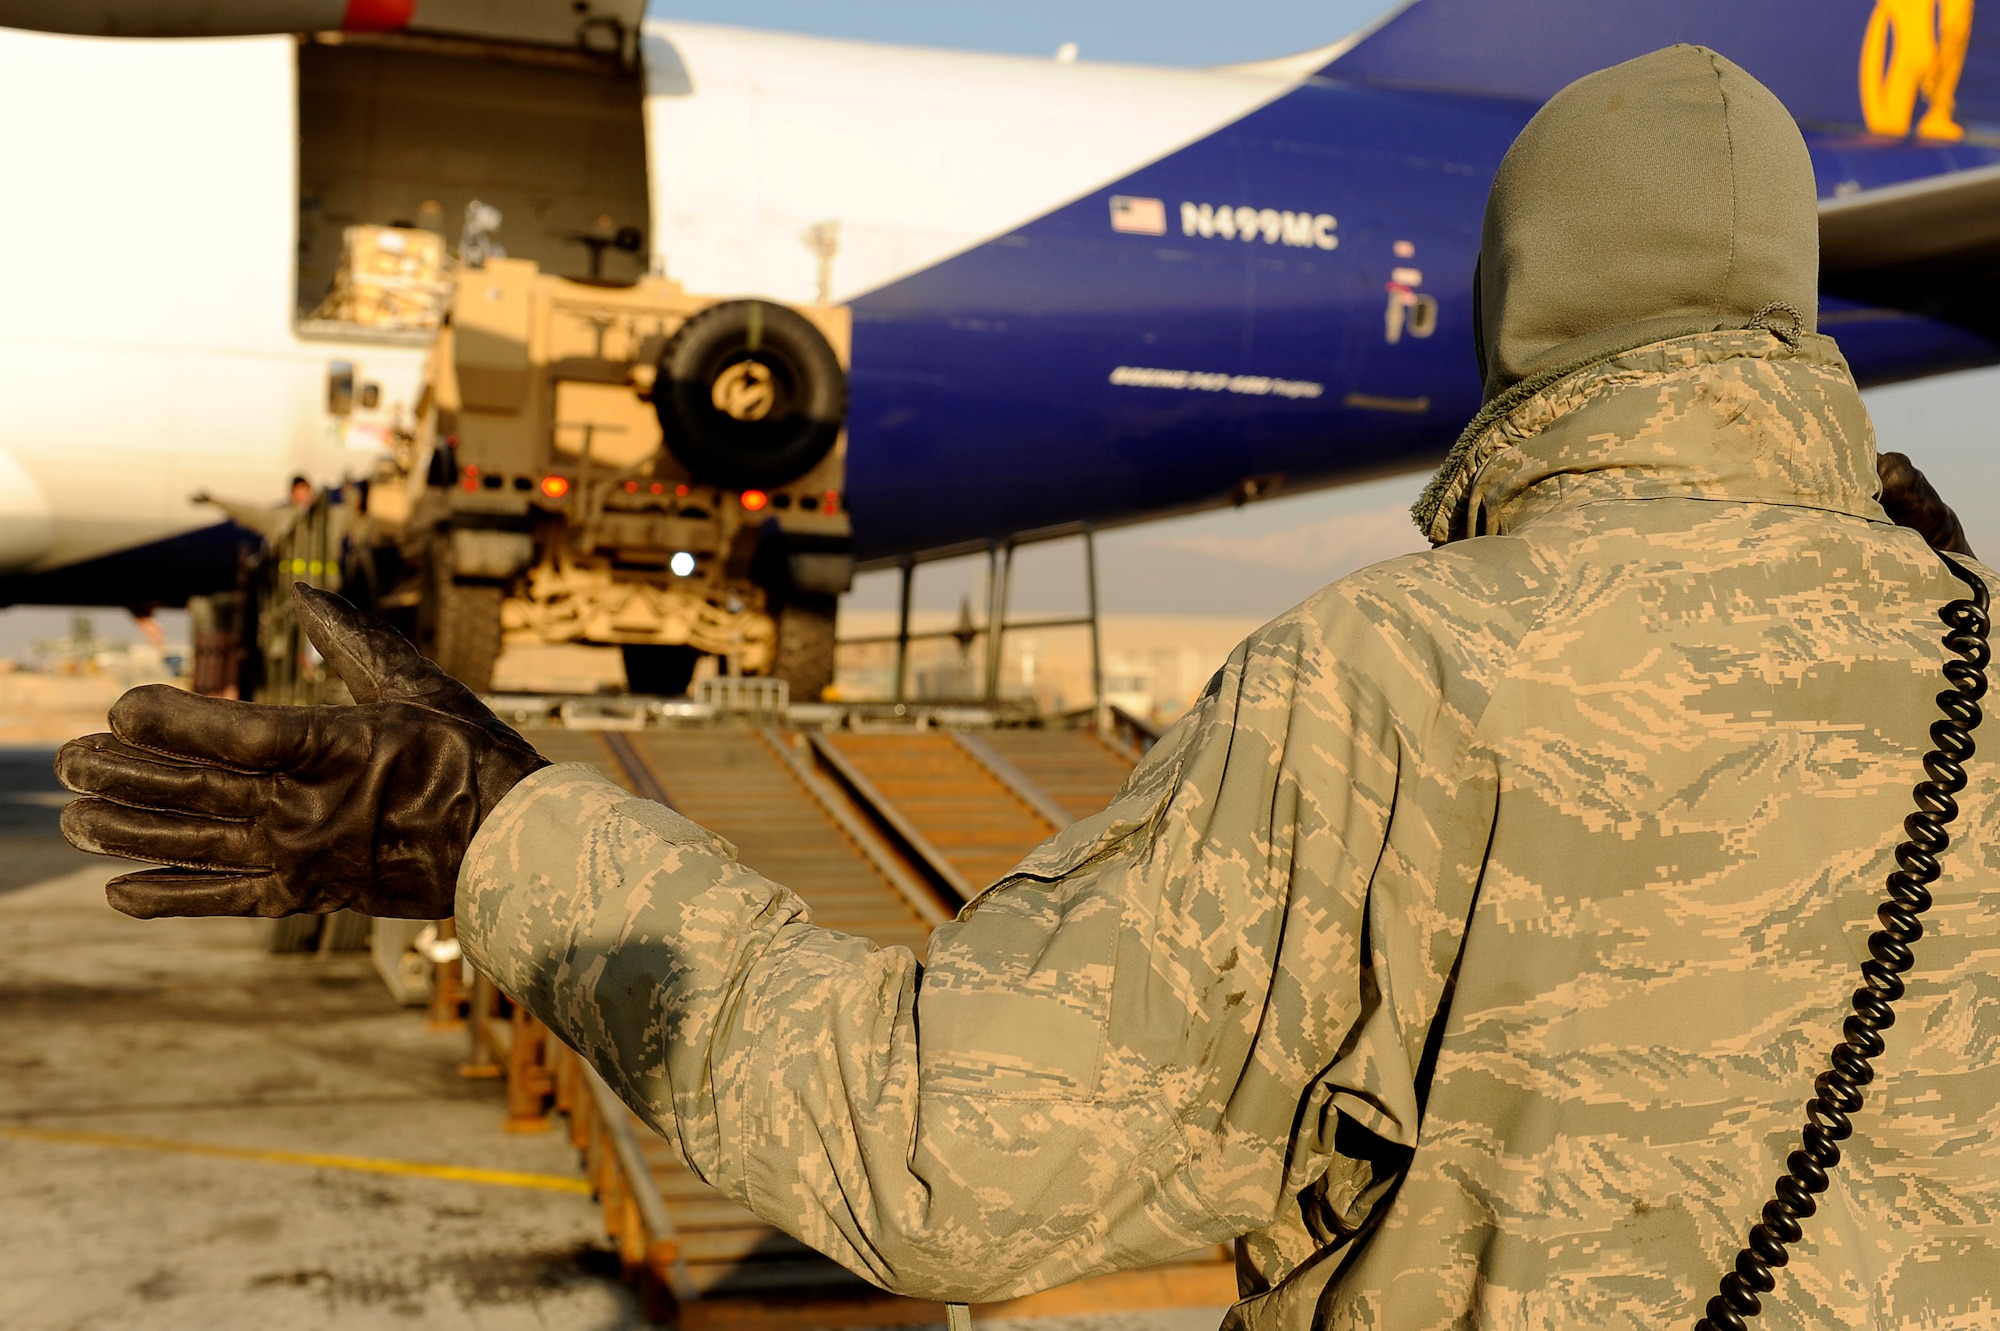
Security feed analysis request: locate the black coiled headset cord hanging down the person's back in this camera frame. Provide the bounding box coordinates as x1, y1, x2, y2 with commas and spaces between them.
1696, 554, 1990, 1331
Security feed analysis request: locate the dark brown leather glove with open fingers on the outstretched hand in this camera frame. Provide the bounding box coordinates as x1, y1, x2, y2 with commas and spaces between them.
56, 584, 548, 919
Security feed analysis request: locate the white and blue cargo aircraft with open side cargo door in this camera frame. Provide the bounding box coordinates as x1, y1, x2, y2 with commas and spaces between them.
0, 0, 2000, 606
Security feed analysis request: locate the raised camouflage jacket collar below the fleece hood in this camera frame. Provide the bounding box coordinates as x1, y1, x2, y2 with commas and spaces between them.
1416, 328, 1888, 546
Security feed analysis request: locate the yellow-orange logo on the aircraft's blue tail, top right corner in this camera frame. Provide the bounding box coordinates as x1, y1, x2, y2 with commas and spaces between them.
1862, 0, 1972, 140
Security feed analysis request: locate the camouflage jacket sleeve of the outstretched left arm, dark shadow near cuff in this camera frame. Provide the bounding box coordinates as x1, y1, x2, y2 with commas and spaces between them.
458, 612, 1422, 1301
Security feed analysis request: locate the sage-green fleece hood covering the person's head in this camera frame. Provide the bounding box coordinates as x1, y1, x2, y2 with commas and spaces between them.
1474, 46, 1820, 400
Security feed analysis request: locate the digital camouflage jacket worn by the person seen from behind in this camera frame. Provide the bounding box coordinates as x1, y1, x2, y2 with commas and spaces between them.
458, 330, 2000, 1331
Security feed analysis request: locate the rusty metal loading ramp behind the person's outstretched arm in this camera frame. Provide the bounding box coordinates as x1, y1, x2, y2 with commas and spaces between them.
472, 725, 1236, 1331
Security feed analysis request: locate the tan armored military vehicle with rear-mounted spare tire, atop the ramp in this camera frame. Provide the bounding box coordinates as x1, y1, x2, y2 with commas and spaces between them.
344, 258, 852, 699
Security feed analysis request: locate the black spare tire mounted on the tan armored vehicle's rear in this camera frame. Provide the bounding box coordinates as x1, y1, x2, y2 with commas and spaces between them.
652, 300, 848, 490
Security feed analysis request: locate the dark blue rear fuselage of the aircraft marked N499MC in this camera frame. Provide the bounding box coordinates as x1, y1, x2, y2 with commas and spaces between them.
848, 78, 2000, 560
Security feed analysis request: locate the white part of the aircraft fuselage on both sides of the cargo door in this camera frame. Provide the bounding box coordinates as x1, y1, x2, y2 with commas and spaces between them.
0, 22, 1326, 602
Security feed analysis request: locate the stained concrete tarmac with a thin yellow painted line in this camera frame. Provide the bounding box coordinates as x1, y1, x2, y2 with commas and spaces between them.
0, 749, 646, 1331
